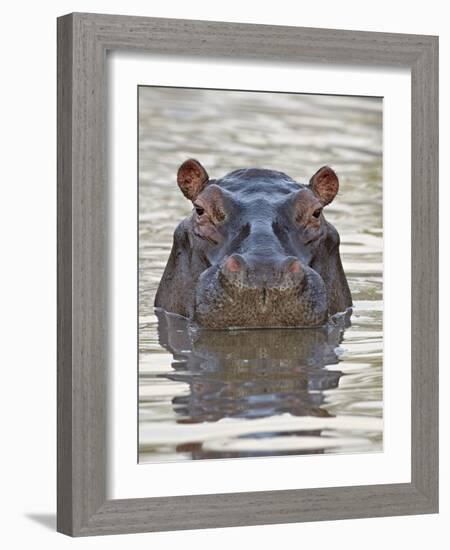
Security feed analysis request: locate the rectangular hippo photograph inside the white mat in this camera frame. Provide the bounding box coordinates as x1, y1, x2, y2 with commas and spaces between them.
137, 85, 383, 464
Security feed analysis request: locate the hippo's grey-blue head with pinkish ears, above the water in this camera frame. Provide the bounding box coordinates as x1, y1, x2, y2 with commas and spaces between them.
155, 159, 352, 328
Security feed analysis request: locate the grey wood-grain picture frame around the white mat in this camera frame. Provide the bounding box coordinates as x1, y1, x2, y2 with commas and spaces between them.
57, 13, 438, 536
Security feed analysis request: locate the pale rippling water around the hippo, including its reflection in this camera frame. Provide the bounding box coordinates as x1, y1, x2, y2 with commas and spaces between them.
139, 87, 383, 462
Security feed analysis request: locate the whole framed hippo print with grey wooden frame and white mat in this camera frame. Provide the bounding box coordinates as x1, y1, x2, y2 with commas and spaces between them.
58, 14, 438, 536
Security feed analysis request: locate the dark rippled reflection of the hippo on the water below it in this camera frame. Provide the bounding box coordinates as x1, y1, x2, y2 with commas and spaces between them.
157, 310, 348, 422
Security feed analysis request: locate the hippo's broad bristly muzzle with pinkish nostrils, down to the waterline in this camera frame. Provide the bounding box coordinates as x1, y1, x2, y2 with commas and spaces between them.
193, 254, 328, 329
